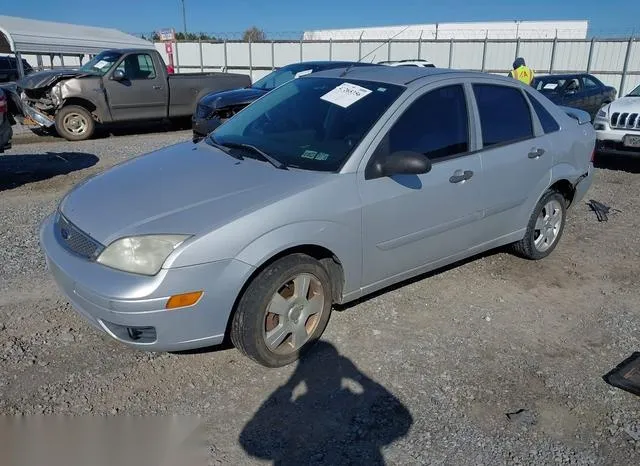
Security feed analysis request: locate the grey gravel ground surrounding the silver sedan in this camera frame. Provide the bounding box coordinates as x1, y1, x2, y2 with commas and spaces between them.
0, 125, 640, 465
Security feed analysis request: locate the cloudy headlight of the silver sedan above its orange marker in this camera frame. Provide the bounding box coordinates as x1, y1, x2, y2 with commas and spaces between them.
98, 235, 189, 275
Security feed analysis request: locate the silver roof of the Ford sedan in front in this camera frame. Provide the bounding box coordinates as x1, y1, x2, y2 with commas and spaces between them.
304, 65, 513, 86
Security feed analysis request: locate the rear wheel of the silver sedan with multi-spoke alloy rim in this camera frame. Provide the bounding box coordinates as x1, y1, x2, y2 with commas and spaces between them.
513, 190, 567, 260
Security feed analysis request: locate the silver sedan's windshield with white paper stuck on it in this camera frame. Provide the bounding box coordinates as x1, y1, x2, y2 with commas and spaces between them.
212, 77, 405, 171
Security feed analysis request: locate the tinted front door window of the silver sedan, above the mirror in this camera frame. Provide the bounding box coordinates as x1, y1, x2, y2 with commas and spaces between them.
381, 85, 469, 162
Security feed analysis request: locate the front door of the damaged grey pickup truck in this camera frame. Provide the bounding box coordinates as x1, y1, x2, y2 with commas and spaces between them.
104, 53, 169, 121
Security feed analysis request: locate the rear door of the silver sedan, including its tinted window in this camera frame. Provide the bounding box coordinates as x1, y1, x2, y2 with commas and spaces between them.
473, 81, 554, 242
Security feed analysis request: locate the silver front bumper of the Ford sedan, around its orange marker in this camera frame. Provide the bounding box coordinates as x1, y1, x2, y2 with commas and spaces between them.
40, 215, 253, 351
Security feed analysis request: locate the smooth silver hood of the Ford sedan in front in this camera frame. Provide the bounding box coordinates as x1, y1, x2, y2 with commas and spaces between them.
60, 142, 329, 245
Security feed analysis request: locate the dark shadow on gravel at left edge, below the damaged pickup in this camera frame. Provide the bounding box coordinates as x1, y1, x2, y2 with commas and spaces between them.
0, 152, 100, 191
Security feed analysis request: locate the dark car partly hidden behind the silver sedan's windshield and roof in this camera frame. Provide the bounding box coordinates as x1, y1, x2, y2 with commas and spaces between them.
191, 61, 377, 141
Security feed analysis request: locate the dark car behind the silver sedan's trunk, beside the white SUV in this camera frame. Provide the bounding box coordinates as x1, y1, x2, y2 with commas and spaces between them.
532, 73, 617, 121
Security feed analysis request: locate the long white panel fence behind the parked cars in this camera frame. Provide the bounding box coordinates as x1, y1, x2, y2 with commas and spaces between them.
156, 38, 640, 94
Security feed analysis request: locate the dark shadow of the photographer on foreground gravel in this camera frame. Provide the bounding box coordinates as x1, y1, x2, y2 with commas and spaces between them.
239, 341, 413, 466
